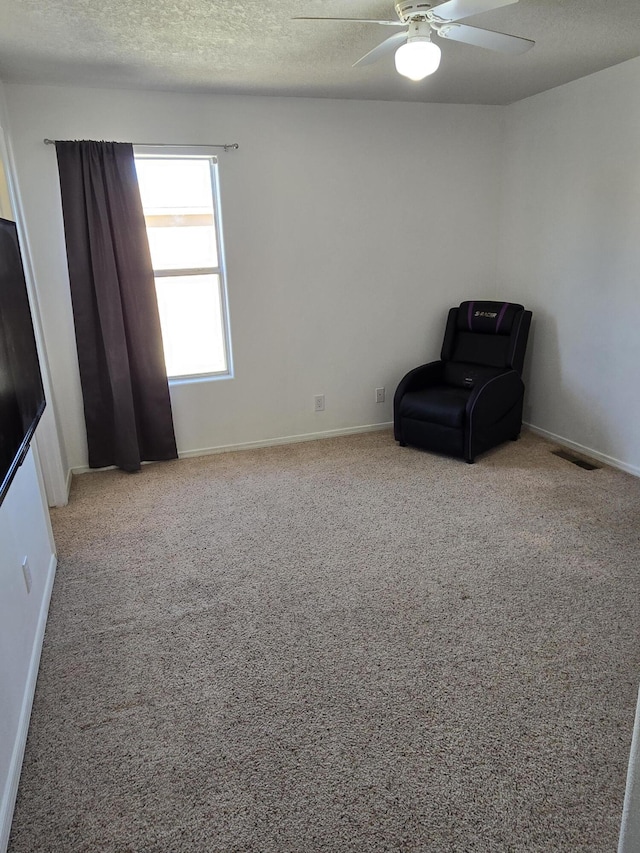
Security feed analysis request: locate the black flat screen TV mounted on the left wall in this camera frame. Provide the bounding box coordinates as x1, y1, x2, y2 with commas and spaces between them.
0, 218, 45, 504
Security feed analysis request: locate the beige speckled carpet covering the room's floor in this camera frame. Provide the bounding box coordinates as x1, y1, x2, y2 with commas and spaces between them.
9, 432, 640, 853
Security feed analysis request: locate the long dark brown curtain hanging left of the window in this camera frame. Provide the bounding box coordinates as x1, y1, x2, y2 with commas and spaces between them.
56, 142, 177, 471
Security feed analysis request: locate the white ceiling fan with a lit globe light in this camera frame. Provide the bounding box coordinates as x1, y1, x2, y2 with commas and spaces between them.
294, 0, 535, 80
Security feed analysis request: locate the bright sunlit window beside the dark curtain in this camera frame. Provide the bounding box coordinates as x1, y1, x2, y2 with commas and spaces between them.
135, 146, 232, 379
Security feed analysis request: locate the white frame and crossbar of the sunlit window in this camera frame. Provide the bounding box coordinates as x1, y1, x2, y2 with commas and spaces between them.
133, 145, 233, 385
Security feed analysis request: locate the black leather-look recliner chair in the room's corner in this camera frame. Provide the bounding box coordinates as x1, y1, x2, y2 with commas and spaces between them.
393, 301, 531, 462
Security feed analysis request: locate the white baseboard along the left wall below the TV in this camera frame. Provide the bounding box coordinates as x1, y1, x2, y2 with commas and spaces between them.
0, 554, 57, 853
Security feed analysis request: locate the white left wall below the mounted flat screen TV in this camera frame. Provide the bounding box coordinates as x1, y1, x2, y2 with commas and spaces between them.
0, 83, 55, 850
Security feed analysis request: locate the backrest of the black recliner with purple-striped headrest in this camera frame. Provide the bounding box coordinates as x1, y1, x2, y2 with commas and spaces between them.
441, 300, 531, 374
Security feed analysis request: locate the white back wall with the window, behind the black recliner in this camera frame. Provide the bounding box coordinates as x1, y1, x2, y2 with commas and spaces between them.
7, 85, 503, 467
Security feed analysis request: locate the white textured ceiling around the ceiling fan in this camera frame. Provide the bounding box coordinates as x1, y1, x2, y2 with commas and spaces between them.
0, 0, 640, 104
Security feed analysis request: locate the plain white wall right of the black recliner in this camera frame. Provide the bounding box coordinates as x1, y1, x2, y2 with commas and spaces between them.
499, 59, 640, 474
